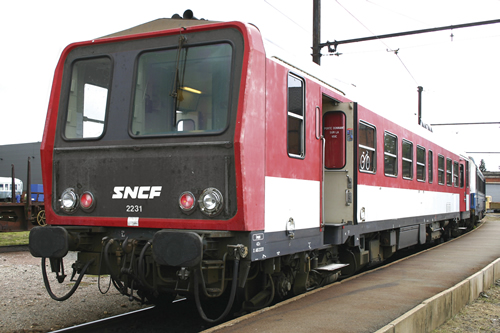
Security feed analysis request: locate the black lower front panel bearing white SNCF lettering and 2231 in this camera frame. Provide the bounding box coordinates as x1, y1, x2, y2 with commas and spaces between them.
54, 144, 236, 219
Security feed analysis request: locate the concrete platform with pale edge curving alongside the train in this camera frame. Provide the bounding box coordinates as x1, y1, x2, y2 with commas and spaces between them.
205, 214, 500, 333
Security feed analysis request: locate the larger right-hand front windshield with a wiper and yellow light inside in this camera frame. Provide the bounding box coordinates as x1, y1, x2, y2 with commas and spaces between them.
131, 43, 232, 137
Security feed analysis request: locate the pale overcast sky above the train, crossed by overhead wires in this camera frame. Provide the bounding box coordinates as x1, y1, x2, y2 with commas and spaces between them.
0, 0, 500, 171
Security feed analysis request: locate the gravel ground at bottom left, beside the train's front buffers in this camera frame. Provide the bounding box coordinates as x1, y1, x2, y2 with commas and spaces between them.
0, 252, 146, 332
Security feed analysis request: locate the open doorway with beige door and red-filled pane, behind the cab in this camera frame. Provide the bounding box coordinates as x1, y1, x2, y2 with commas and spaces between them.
322, 96, 357, 225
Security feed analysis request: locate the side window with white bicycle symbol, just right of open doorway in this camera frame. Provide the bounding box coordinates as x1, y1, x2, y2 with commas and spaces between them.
358, 122, 377, 173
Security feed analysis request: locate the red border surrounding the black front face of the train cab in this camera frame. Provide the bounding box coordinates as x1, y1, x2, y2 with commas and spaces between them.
41, 22, 265, 230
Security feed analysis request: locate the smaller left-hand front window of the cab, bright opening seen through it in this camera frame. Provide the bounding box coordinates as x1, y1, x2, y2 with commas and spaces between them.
64, 58, 111, 139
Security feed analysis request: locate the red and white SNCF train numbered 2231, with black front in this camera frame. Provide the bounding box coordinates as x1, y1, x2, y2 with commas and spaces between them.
30, 11, 484, 320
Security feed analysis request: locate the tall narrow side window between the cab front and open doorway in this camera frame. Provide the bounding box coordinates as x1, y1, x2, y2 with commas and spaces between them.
287, 74, 305, 158
